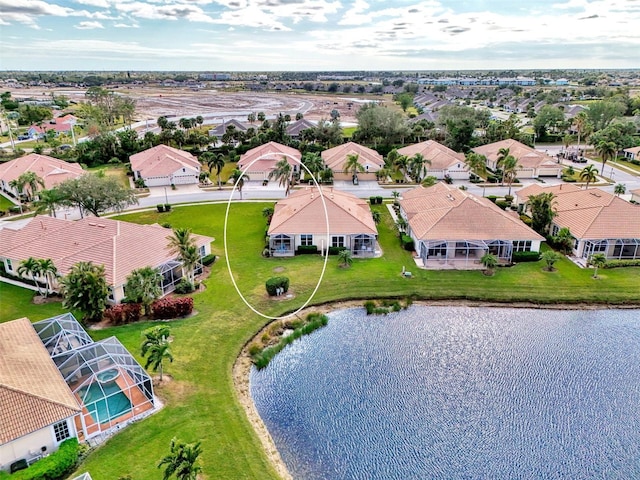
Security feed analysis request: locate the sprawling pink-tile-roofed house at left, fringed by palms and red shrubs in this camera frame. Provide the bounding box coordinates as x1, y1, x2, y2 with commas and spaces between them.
0, 216, 213, 303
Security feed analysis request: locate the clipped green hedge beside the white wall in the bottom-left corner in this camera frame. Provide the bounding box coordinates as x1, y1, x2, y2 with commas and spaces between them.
0, 438, 80, 480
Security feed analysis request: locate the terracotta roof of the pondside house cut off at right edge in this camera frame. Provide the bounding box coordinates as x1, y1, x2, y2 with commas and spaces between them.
518, 185, 640, 240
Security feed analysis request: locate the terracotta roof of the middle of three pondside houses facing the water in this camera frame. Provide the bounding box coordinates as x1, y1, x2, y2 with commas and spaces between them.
400, 183, 544, 244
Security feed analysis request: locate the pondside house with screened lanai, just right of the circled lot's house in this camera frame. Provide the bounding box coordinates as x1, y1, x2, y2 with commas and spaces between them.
400, 182, 544, 269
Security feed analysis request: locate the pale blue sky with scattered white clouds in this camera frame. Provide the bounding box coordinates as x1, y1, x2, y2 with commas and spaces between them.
0, 0, 640, 72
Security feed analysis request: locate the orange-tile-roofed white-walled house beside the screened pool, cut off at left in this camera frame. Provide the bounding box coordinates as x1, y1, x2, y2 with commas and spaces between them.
0, 318, 81, 471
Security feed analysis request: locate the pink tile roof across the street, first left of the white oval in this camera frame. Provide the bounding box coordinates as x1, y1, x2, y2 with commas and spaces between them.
129, 145, 200, 178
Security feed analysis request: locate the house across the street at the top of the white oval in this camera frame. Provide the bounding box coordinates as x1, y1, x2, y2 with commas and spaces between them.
238, 142, 302, 182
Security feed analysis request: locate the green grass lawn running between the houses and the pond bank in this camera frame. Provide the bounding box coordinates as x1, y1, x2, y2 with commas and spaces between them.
0, 202, 640, 480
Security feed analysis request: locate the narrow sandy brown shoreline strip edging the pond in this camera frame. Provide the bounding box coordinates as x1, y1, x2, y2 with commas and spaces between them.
233, 299, 640, 480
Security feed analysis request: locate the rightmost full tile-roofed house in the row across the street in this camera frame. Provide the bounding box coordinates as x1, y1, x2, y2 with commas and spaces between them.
472, 139, 563, 178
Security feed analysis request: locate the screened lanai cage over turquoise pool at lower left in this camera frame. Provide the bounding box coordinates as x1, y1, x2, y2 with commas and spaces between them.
33, 313, 154, 440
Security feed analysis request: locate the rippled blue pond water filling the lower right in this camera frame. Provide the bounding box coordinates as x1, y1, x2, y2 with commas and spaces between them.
250, 306, 640, 479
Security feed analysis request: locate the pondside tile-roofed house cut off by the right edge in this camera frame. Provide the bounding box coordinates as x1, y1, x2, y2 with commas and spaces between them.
517, 184, 640, 260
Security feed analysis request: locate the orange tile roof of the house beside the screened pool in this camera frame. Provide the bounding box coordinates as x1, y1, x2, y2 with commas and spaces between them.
0, 318, 80, 445
